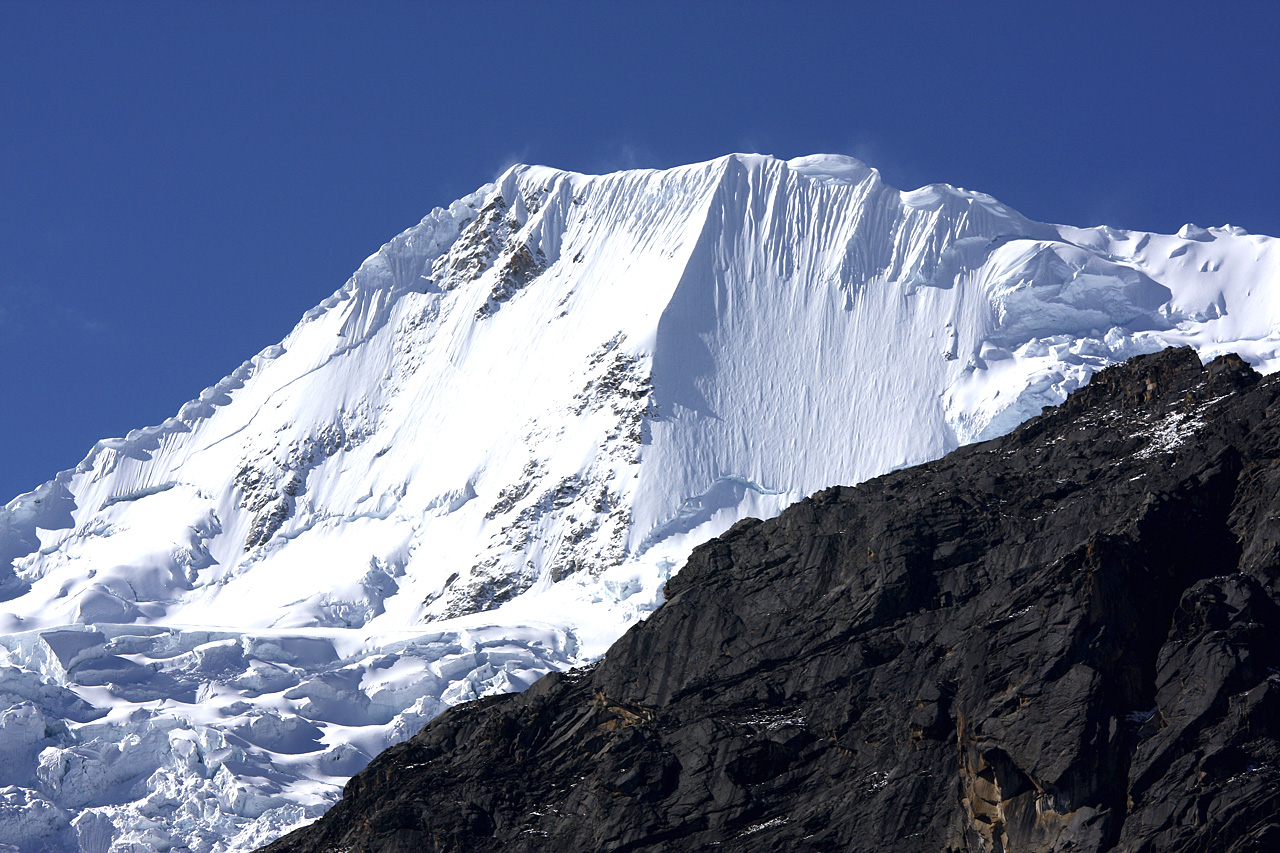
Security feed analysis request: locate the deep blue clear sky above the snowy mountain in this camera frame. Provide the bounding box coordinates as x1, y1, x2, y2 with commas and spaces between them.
0, 0, 1280, 502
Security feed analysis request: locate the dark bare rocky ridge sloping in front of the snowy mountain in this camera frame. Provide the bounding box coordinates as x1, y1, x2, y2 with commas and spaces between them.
266, 350, 1280, 853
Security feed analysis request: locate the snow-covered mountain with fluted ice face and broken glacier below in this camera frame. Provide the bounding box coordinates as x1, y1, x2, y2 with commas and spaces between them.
0, 155, 1280, 853
